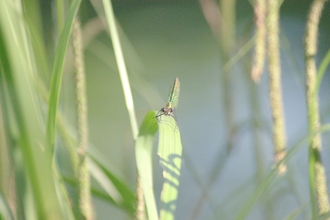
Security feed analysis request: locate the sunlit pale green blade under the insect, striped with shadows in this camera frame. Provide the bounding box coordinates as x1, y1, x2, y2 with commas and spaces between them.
158, 117, 182, 220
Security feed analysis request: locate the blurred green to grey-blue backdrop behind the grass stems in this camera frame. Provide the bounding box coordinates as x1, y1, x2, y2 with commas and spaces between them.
1, 0, 330, 220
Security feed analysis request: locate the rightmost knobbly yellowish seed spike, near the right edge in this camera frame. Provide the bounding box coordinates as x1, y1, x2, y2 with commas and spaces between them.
305, 0, 330, 219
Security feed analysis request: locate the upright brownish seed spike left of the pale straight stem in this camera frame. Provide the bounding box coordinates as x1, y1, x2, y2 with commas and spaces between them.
72, 17, 94, 220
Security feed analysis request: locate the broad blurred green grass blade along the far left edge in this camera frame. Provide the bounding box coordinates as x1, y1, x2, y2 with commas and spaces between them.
0, 0, 61, 219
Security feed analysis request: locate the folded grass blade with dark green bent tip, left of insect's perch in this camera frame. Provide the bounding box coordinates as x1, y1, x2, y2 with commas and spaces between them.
135, 111, 158, 220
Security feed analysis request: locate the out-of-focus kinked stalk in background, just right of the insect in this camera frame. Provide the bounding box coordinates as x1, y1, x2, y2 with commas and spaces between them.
190, 0, 238, 219
